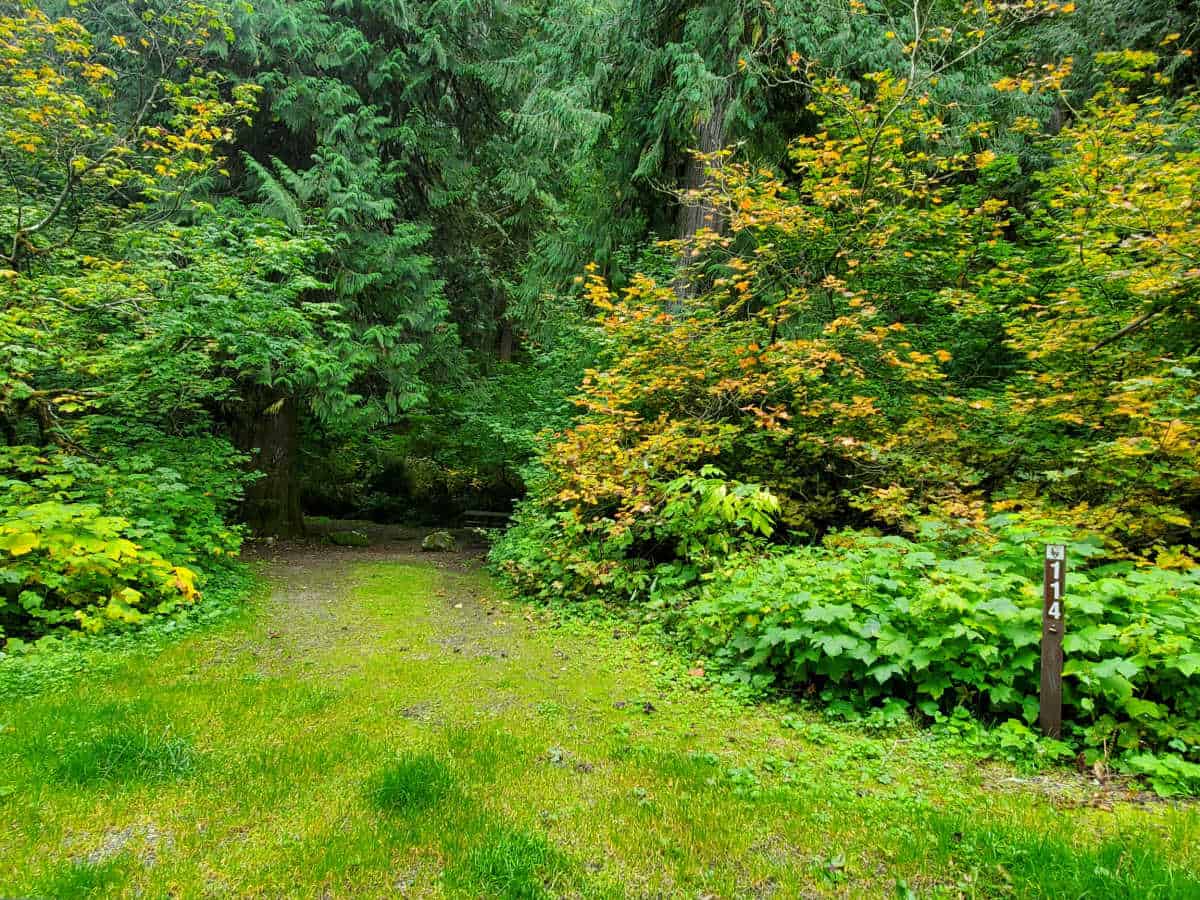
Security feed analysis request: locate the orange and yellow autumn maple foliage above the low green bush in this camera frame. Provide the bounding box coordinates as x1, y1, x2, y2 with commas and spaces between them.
501, 54, 1200, 602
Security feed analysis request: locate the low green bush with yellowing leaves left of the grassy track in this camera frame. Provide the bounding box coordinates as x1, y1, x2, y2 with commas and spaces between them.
0, 446, 240, 646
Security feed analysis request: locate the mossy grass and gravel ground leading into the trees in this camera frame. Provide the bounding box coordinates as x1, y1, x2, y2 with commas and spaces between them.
0, 544, 1200, 899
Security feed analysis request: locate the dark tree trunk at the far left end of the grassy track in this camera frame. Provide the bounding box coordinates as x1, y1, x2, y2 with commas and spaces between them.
228, 385, 304, 538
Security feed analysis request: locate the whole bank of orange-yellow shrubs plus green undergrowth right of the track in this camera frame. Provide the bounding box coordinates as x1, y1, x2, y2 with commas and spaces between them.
497, 42, 1200, 790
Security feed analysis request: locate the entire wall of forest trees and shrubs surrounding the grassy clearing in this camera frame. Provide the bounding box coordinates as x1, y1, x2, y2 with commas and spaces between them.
0, 0, 1200, 778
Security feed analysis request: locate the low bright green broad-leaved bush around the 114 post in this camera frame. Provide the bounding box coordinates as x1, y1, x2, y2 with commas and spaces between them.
679, 522, 1200, 787
